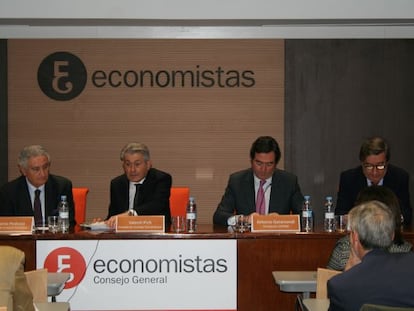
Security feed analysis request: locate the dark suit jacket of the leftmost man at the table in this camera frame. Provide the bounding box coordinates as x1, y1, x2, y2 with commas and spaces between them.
0, 174, 75, 226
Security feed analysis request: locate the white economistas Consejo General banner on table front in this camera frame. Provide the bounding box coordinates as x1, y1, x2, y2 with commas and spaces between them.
36, 240, 237, 311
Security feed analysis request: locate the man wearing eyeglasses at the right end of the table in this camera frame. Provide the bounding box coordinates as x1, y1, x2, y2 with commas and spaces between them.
335, 137, 412, 224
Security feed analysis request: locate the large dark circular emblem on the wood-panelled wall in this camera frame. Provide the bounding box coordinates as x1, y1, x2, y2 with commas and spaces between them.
37, 52, 87, 101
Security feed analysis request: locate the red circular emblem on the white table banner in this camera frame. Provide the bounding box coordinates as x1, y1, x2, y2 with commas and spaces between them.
44, 247, 86, 289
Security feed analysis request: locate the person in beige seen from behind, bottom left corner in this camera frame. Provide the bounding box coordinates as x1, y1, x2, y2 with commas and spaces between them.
0, 246, 35, 311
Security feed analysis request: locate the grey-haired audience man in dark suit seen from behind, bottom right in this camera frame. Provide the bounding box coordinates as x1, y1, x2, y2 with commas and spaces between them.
327, 201, 414, 311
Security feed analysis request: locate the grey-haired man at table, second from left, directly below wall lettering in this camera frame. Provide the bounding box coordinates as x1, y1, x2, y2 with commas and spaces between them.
106, 143, 172, 226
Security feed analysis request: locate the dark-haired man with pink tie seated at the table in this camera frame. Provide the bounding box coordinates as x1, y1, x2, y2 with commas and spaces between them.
213, 136, 303, 225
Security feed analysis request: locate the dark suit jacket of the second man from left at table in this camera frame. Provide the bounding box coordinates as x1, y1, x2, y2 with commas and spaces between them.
107, 168, 172, 225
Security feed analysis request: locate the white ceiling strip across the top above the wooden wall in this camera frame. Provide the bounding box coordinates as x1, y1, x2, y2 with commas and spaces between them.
0, 0, 414, 38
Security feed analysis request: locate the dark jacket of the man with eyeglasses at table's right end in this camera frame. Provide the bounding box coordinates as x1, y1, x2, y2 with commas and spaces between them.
335, 164, 412, 224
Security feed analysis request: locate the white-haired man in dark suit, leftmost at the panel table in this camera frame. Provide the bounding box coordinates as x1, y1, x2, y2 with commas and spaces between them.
0, 145, 75, 226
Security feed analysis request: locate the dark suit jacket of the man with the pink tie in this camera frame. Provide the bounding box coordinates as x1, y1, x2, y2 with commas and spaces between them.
213, 169, 303, 225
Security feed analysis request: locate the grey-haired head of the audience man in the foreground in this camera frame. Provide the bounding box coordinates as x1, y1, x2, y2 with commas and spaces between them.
348, 201, 395, 251
